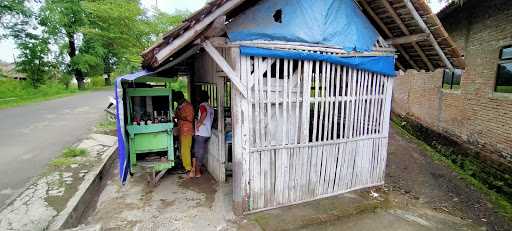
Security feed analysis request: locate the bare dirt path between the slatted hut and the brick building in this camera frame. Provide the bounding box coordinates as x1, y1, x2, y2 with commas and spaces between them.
386, 128, 512, 230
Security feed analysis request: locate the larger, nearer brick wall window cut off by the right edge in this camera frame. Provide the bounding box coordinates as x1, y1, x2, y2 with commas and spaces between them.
494, 46, 512, 93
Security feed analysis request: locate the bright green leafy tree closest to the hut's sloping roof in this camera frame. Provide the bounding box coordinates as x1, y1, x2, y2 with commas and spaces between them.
81, 0, 189, 84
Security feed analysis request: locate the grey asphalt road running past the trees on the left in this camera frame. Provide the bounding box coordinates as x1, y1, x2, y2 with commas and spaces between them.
0, 90, 113, 207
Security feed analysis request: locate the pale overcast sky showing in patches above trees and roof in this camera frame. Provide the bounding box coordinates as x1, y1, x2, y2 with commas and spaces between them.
0, 0, 442, 62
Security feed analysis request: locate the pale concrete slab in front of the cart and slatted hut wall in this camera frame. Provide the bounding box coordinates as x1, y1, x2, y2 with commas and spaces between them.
85, 169, 482, 231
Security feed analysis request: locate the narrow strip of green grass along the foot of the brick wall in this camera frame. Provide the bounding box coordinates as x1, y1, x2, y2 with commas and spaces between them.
392, 120, 512, 221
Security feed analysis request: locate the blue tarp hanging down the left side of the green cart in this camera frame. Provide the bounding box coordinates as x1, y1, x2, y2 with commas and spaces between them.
114, 70, 153, 184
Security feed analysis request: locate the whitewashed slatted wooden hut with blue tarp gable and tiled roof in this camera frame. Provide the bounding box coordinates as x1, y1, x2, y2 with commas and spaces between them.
116, 0, 464, 214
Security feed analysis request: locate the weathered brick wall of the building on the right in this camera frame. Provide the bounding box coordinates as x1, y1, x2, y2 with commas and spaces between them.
393, 0, 512, 164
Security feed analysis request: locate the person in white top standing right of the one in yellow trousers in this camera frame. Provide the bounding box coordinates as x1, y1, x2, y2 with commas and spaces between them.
189, 91, 214, 177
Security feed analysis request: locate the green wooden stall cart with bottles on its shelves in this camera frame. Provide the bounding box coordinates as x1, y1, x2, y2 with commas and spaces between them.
115, 72, 179, 184
